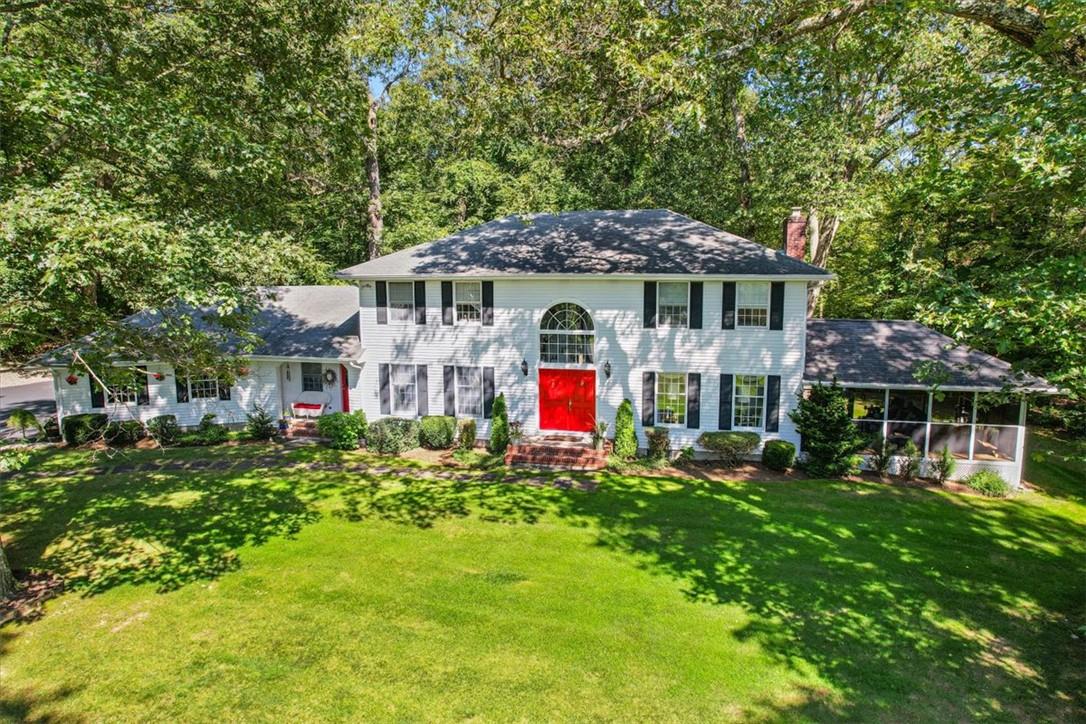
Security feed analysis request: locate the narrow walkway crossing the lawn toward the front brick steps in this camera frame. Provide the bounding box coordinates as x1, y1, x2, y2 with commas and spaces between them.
10, 455, 596, 492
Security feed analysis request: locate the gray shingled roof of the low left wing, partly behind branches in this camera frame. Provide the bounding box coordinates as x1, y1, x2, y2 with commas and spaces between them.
39, 285, 361, 366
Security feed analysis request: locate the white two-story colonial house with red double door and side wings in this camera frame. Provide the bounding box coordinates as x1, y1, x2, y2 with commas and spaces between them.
50, 209, 1056, 483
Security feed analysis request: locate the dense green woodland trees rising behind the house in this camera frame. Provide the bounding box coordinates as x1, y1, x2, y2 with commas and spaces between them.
0, 0, 1086, 425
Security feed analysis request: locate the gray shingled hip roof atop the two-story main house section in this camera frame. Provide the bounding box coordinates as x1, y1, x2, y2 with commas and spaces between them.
336, 208, 831, 279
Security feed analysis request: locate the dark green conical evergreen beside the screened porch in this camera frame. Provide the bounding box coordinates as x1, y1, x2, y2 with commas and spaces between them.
788, 380, 867, 478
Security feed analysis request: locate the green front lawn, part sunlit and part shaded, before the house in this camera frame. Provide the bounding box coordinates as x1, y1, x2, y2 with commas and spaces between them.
0, 437, 1086, 721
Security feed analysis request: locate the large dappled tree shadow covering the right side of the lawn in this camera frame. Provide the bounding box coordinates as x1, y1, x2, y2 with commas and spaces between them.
334, 474, 1086, 721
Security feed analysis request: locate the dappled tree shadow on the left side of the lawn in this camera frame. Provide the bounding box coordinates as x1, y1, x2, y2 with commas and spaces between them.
4, 471, 320, 594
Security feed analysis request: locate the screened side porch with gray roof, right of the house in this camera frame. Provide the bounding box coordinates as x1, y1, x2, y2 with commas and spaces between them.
804, 319, 1059, 486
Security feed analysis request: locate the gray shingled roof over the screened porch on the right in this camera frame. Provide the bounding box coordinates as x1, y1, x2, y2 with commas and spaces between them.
804, 319, 1057, 393
